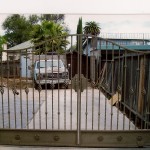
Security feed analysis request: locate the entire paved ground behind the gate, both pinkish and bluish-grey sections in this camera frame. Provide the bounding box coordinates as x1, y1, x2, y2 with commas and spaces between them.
0, 88, 135, 130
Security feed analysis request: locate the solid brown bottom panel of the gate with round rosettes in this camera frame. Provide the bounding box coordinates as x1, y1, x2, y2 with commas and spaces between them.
0, 129, 150, 147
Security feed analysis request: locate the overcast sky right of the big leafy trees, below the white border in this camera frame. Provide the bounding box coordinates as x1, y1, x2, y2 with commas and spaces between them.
66, 14, 150, 33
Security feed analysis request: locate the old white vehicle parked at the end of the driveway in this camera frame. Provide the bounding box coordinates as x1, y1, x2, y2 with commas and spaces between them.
34, 59, 69, 89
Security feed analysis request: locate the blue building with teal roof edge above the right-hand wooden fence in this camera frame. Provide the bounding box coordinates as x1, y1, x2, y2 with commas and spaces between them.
83, 35, 150, 56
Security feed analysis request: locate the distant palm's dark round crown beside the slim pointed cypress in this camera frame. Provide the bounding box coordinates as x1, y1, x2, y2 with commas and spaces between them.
83, 21, 101, 36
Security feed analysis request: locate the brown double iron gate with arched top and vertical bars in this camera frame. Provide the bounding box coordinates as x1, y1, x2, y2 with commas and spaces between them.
0, 35, 150, 147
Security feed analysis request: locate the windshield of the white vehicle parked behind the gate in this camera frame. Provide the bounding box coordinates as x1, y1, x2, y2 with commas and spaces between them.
37, 60, 64, 68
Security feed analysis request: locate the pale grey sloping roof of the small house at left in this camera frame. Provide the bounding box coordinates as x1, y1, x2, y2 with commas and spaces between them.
8, 40, 34, 50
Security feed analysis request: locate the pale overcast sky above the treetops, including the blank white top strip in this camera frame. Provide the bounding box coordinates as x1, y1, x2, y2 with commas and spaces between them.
0, 0, 150, 35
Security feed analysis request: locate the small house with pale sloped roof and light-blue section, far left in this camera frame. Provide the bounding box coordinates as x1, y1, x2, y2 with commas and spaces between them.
4, 40, 34, 77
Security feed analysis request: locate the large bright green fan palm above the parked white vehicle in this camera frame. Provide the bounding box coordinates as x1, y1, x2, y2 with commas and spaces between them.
31, 21, 69, 53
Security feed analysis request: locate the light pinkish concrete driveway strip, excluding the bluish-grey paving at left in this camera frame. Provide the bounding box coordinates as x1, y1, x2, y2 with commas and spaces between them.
29, 88, 135, 130
